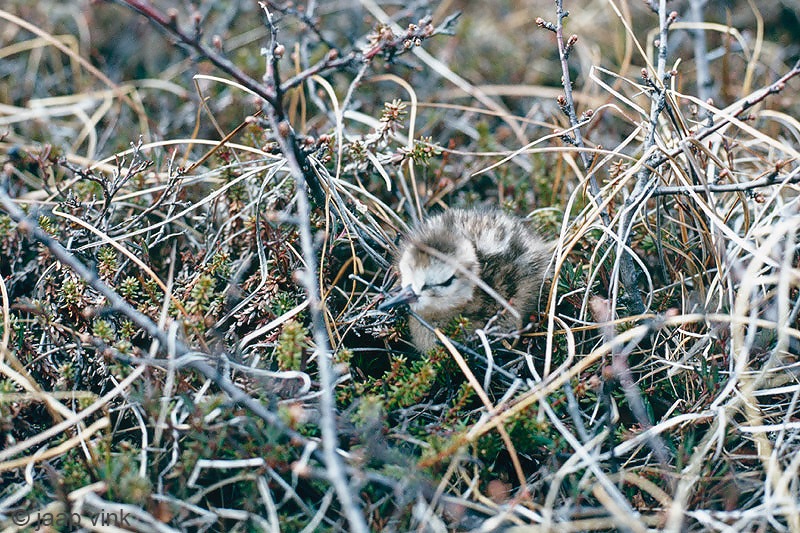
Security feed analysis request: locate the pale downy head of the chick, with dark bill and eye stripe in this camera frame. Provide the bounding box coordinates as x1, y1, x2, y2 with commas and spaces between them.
379, 228, 479, 318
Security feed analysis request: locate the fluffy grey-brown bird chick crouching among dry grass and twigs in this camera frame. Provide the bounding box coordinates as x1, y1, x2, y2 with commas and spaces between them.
379, 209, 553, 352
